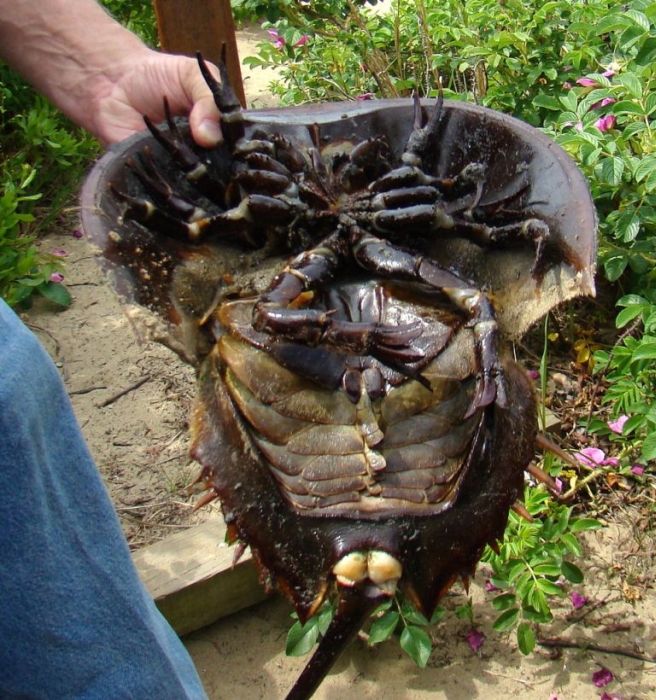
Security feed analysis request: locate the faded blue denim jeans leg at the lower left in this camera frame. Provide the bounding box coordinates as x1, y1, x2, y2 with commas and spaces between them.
0, 300, 206, 700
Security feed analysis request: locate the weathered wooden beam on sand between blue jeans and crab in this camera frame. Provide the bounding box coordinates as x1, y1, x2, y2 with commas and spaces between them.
132, 518, 267, 634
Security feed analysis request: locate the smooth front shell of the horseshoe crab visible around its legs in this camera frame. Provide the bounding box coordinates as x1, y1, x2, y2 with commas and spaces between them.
81, 100, 596, 359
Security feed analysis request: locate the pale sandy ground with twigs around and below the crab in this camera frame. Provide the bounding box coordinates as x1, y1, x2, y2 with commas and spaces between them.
25, 23, 656, 700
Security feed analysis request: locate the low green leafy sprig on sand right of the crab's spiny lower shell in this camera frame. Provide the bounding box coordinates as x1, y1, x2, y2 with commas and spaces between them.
483, 487, 600, 654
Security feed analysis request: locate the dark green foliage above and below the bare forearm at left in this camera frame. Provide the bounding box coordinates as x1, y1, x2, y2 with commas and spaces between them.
0, 0, 156, 306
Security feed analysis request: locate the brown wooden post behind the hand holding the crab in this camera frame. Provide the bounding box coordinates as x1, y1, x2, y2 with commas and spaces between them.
153, 0, 246, 107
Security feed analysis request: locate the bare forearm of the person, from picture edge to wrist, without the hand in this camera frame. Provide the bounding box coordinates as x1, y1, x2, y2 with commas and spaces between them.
0, 0, 150, 131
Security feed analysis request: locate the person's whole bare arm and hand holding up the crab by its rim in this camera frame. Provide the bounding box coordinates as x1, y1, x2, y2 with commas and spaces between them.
0, 0, 221, 147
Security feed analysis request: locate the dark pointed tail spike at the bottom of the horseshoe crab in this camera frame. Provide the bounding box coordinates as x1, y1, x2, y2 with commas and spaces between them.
286, 586, 388, 700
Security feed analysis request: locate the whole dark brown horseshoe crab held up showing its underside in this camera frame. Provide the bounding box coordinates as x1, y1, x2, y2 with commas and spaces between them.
82, 59, 596, 698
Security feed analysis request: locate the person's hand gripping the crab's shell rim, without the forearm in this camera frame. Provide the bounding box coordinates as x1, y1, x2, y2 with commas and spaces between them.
87, 49, 222, 148
